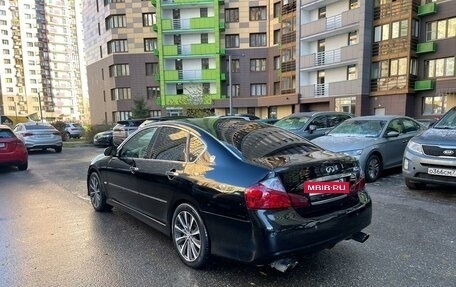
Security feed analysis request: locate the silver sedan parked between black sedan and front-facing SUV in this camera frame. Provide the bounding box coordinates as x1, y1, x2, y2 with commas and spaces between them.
312, 116, 426, 182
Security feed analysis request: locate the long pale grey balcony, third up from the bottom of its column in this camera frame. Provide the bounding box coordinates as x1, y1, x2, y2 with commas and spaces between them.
300, 8, 363, 42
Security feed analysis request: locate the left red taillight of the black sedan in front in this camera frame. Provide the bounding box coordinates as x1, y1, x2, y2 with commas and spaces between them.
244, 177, 309, 209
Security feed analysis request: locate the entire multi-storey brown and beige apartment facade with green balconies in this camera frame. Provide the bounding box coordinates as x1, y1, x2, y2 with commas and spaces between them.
84, 0, 456, 125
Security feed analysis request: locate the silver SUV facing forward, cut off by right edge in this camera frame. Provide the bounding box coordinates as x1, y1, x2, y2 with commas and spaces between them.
402, 106, 456, 189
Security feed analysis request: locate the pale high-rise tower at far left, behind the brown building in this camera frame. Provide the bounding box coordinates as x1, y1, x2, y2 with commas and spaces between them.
0, 0, 88, 121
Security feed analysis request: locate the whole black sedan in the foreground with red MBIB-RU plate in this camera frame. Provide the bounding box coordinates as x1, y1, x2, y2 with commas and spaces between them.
87, 118, 372, 271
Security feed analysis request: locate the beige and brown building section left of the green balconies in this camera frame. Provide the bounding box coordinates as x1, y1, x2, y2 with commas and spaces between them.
83, 0, 161, 124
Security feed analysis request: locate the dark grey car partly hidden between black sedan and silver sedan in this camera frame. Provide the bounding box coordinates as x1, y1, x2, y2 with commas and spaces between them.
274, 112, 353, 140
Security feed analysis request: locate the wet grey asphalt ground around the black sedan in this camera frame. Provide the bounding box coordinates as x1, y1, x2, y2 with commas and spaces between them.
0, 146, 456, 287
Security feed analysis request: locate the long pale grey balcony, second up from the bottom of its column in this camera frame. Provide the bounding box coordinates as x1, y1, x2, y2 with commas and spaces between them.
299, 44, 359, 71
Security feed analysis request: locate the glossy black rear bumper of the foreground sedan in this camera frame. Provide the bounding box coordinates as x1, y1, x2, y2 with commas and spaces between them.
208, 193, 372, 264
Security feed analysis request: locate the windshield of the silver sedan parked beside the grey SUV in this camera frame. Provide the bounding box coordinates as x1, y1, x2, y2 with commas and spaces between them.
328, 120, 386, 137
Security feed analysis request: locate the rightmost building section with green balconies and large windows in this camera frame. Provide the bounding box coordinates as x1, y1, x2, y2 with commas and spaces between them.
410, 0, 456, 118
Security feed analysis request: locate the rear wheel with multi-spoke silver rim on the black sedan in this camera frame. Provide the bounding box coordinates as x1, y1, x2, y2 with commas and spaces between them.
171, 203, 210, 269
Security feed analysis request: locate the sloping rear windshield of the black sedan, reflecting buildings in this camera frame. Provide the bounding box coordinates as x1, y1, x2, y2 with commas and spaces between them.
187, 118, 320, 159
